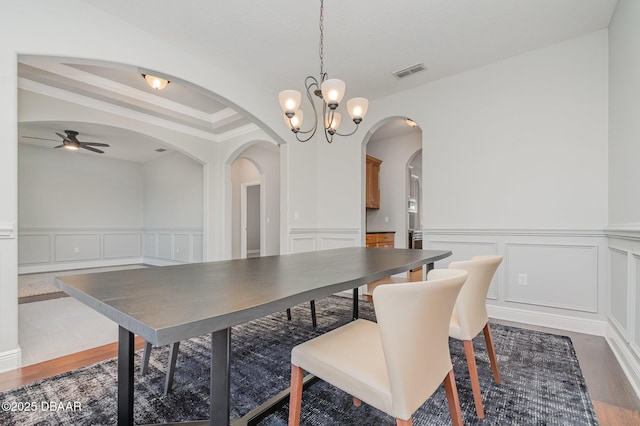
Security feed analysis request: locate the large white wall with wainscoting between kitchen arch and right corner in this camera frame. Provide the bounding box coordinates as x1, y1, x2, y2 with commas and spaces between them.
368, 31, 609, 334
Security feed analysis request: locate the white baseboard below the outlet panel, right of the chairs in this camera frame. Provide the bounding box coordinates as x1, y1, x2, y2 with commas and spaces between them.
487, 305, 607, 336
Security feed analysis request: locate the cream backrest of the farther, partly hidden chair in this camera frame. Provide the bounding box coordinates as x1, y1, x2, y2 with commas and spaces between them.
449, 255, 503, 340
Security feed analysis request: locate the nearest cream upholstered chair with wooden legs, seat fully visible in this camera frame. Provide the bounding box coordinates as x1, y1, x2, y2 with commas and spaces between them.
289, 269, 467, 425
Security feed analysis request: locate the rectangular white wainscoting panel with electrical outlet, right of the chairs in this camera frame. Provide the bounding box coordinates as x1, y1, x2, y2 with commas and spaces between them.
505, 243, 598, 313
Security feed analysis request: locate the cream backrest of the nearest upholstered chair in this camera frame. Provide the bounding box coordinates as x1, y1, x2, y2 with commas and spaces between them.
373, 269, 467, 418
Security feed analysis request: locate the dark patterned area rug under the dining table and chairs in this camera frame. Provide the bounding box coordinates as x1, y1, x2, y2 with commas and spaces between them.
0, 296, 597, 425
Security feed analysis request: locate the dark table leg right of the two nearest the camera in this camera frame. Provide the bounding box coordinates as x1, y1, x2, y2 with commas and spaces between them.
209, 328, 231, 426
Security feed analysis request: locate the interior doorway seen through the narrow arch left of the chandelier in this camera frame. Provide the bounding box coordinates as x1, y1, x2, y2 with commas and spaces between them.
240, 182, 261, 259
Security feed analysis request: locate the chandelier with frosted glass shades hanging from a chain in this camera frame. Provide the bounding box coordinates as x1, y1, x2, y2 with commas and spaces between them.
278, 0, 369, 143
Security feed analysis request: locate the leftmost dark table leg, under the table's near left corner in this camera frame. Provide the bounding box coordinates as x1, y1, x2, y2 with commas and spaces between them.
118, 326, 134, 426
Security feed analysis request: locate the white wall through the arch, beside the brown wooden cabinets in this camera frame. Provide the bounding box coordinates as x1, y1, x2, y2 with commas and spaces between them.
367, 132, 422, 248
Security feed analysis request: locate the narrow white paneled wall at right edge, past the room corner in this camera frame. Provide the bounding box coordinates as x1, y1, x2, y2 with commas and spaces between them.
607, 0, 640, 395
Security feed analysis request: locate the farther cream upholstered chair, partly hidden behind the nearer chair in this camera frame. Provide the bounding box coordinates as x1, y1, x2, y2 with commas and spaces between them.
440, 255, 503, 419
